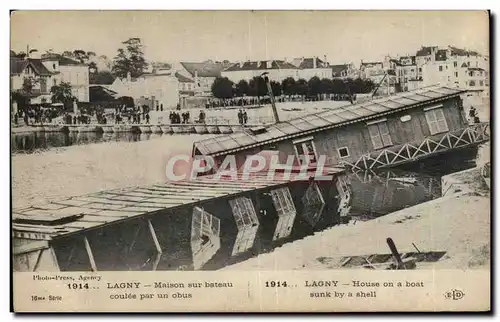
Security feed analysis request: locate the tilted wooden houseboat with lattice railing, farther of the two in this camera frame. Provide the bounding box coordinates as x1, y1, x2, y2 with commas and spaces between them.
193, 86, 489, 170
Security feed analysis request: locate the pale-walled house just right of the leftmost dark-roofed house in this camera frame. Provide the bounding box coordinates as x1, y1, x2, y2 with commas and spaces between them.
41, 54, 90, 102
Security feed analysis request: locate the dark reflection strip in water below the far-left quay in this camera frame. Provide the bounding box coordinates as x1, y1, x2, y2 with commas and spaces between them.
11, 132, 175, 153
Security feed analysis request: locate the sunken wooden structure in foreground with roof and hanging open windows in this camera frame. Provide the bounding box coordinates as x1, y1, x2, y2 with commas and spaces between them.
12, 169, 349, 271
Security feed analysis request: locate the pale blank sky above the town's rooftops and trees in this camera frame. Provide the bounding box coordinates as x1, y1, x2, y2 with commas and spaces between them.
11, 11, 489, 64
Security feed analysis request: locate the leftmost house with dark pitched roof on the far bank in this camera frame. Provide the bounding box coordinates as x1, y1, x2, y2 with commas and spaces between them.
10, 57, 54, 104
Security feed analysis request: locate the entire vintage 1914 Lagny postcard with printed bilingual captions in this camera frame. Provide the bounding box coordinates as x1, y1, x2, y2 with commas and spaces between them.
10, 10, 491, 312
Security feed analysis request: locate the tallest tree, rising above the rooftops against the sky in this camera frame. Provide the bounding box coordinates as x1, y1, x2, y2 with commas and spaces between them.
111, 38, 148, 78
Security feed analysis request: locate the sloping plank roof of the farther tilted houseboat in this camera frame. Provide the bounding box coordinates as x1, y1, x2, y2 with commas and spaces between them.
193, 86, 465, 156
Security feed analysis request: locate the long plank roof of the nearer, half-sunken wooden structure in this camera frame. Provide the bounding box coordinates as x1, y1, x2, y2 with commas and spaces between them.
12, 168, 343, 240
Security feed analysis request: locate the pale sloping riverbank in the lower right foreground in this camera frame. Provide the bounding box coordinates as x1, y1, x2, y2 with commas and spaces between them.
224, 191, 490, 270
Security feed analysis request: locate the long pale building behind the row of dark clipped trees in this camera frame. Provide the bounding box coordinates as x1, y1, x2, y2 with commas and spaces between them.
221, 60, 300, 83
